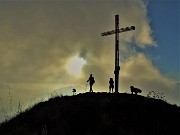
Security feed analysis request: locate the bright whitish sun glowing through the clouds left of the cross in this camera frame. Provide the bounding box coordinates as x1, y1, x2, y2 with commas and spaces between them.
67, 55, 86, 75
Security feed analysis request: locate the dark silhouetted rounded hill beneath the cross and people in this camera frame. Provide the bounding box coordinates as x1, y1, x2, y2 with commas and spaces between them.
0, 93, 180, 135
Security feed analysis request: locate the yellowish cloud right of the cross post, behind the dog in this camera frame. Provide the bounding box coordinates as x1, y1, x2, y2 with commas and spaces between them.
120, 53, 180, 103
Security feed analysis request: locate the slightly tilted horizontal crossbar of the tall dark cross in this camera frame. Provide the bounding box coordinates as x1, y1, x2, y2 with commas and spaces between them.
101, 26, 135, 36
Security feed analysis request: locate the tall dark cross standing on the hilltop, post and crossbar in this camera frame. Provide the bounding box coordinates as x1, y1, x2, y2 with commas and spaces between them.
101, 14, 135, 93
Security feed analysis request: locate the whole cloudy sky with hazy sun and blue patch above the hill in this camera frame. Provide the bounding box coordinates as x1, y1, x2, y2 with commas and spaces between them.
0, 0, 180, 121
